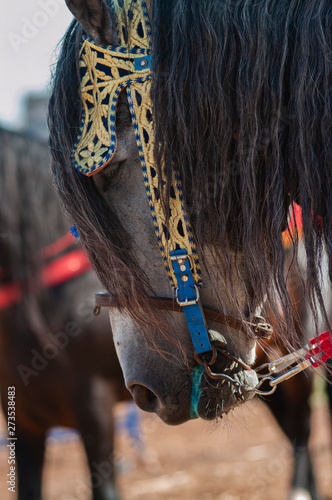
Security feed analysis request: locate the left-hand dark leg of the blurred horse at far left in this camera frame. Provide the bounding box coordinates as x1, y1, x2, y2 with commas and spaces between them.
15, 429, 45, 500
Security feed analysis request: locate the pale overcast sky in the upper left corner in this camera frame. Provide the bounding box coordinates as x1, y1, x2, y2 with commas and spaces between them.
0, 0, 72, 129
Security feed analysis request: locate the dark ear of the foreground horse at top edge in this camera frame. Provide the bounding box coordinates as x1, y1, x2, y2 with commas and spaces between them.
66, 0, 118, 45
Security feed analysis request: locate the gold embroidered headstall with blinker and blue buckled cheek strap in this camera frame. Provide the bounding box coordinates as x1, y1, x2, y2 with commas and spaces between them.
72, 14, 222, 358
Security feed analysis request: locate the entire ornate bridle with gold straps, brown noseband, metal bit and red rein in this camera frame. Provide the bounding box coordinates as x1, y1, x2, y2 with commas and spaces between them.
72, 0, 332, 406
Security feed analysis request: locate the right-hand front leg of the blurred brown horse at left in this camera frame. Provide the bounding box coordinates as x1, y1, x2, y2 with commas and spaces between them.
76, 377, 120, 500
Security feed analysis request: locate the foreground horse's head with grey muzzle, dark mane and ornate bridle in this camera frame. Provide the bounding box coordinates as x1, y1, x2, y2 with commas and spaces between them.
49, 0, 331, 424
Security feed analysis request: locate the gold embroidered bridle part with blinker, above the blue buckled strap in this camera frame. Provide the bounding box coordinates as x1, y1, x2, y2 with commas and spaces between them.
72, 0, 202, 288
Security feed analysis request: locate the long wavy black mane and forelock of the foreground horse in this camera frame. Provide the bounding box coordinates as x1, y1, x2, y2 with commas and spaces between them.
50, 0, 332, 340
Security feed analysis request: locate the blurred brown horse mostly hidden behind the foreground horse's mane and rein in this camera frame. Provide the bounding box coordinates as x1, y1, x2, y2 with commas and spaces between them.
256, 254, 326, 500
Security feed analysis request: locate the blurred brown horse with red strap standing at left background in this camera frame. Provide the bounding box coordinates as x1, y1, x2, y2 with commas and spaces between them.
0, 122, 130, 500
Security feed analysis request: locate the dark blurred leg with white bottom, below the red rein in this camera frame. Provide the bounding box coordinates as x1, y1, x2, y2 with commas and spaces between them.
265, 373, 319, 500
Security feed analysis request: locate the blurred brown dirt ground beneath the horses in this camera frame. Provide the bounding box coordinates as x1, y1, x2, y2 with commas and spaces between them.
0, 378, 332, 500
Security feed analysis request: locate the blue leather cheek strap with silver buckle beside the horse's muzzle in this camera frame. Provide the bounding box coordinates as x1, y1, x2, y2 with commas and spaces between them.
170, 249, 212, 354
